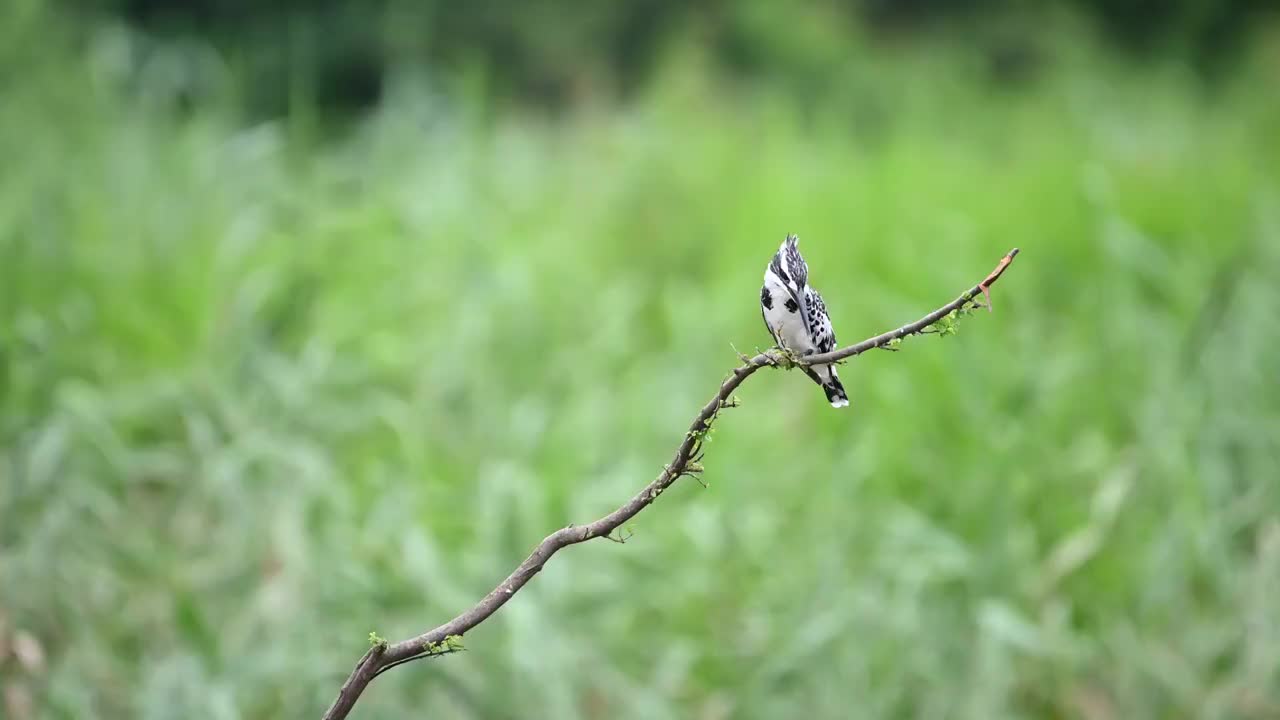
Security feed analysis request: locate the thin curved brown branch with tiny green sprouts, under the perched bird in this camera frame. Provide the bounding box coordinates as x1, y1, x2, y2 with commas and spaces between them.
324, 247, 1018, 720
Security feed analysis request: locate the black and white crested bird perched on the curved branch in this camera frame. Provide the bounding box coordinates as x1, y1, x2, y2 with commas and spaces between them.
760, 234, 849, 407
